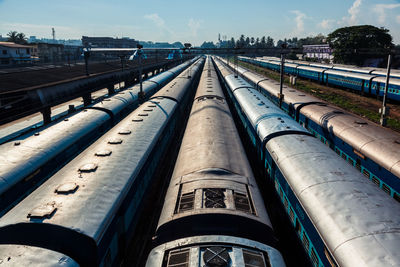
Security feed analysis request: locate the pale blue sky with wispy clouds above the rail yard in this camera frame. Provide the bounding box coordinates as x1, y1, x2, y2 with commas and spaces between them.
0, 0, 400, 45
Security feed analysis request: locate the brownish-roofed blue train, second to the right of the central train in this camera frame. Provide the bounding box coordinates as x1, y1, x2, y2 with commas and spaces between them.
222, 56, 400, 202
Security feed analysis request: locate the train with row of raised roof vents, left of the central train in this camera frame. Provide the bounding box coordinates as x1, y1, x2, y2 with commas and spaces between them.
0, 58, 204, 266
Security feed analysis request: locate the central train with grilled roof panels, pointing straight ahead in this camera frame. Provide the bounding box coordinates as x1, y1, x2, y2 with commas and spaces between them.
146, 57, 285, 267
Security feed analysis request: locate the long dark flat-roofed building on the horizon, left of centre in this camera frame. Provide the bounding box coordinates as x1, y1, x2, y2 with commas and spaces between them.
82, 36, 138, 48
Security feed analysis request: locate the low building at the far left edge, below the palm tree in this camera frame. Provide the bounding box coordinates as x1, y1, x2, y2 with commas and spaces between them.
0, 42, 32, 65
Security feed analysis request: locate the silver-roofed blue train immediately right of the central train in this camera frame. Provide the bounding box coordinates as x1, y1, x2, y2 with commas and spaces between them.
214, 59, 400, 266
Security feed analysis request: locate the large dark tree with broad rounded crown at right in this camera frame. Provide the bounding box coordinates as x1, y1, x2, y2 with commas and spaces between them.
327, 25, 394, 65
